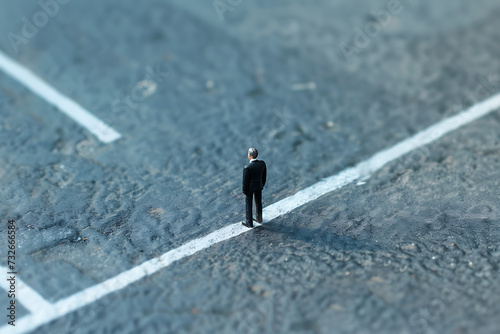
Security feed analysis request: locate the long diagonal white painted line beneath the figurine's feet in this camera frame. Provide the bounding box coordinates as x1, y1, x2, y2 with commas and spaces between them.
0, 94, 500, 334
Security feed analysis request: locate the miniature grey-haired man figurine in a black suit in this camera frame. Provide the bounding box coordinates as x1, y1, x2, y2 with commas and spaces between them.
243, 148, 267, 227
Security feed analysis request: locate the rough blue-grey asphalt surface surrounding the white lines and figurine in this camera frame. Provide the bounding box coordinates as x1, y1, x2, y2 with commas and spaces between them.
0, 0, 500, 333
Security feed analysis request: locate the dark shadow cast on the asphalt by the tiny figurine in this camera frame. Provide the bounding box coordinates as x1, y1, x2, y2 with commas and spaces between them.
255, 221, 383, 251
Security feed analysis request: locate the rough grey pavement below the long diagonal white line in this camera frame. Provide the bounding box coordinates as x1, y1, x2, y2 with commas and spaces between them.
33, 109, 500, 333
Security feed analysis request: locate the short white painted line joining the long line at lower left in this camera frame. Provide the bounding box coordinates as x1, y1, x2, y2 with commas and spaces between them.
0, 267, 53, 314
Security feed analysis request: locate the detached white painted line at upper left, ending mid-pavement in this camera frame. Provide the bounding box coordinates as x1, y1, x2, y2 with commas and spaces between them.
0, 51, 121, 143
